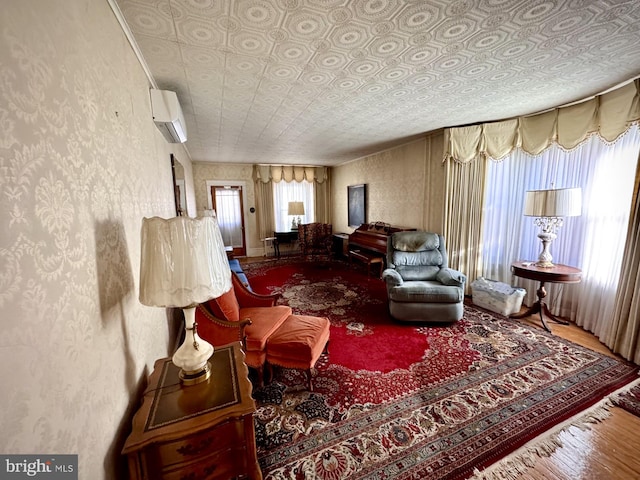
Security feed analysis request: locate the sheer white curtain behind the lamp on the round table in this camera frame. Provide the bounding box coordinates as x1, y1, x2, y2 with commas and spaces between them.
482, 124, 640, 336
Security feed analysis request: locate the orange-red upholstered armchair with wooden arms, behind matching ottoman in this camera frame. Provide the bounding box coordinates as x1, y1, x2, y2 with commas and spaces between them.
196, 272, 291, 384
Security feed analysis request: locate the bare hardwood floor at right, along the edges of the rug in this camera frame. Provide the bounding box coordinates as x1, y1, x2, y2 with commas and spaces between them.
504, 316, 640, 480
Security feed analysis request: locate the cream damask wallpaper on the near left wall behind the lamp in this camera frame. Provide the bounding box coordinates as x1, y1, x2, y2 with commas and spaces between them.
0, 0, 194, 479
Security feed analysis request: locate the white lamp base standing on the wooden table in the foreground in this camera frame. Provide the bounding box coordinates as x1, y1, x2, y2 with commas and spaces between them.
172, 307, 213, 385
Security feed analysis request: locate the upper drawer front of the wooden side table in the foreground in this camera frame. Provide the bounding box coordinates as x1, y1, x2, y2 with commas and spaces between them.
156, 420, 245, 466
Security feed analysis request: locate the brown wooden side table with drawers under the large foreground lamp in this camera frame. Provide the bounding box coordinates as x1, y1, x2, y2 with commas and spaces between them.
122, 343, 262, 480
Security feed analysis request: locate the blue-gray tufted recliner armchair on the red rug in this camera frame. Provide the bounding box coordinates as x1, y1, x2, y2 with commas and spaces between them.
382, 231, 467, 323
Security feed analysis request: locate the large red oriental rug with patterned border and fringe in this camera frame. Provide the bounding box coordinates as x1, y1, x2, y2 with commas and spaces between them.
245, 259, 638, 480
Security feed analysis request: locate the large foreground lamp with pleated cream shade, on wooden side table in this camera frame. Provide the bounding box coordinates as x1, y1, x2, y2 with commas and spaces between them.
139, 217, 231, 385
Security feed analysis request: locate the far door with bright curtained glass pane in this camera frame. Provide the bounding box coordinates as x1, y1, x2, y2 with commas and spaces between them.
211, 185, 247, 257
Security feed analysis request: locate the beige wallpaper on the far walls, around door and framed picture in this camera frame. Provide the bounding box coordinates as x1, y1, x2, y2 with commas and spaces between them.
193, 131, 444, 244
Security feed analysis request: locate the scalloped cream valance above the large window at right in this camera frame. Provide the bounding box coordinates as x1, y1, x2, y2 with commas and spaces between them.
444, 79, 640, 163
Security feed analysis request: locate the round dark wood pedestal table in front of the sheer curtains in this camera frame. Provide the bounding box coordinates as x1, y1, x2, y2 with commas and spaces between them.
509, 262, 582, 332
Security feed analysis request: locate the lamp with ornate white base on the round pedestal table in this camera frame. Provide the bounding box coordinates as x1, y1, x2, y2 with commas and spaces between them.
524, 188, 582, 268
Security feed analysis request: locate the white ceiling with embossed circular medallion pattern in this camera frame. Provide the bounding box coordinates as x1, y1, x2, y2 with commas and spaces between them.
117, 0, 640, 166
